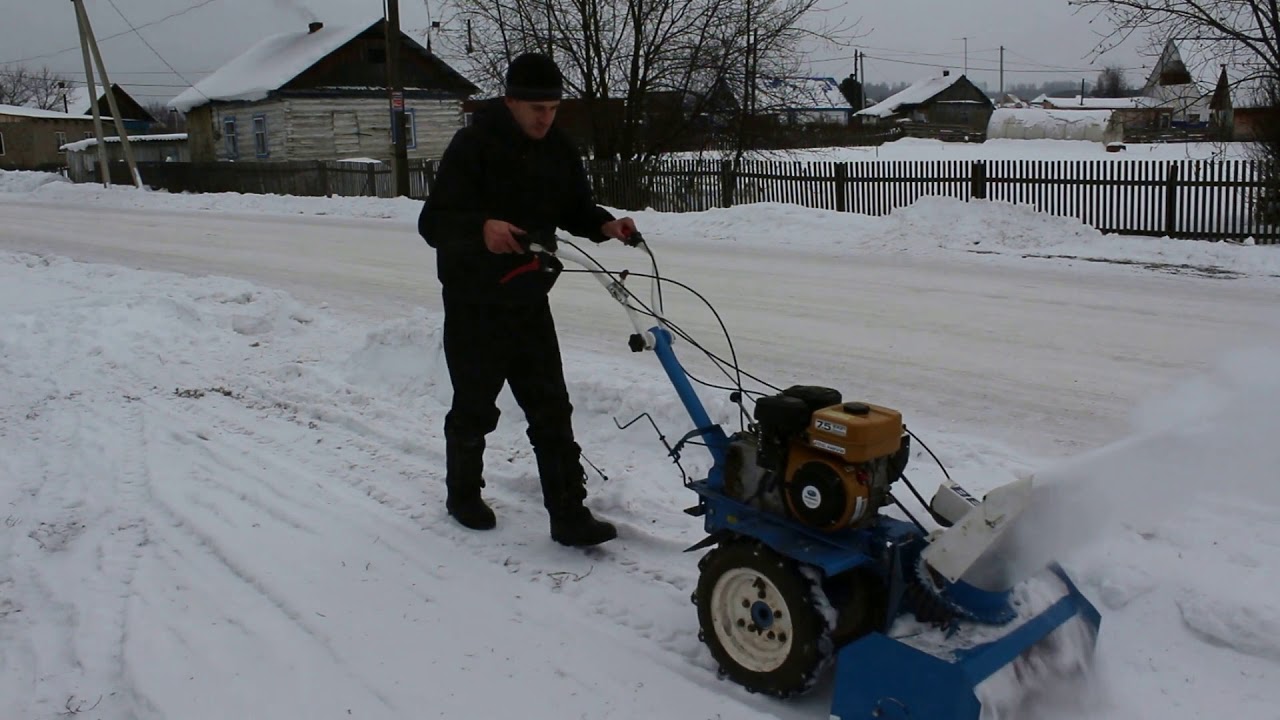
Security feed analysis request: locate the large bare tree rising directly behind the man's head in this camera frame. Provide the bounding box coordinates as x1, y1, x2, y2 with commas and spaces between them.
439, 0, 860, 159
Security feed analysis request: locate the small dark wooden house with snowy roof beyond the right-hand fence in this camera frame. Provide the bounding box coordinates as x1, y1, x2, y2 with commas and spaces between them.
854, 70, 996, 133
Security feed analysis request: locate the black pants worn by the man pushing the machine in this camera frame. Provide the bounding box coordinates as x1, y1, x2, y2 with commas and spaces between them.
444, 297, 586, 512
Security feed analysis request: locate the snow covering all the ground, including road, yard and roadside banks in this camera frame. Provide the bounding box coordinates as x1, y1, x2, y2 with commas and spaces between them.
0, 162, 1280, 720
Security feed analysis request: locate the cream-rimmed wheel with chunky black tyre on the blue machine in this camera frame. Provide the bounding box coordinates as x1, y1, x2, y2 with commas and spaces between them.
694, 541, 835, 697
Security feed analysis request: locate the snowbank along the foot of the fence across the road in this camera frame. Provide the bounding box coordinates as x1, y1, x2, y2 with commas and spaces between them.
0, 161, 1280, 277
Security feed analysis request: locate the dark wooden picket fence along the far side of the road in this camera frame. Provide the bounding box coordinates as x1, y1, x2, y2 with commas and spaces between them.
111, 159, 1280, 243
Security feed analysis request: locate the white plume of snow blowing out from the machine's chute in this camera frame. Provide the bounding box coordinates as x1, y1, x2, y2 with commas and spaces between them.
1001, 347, 1280, 577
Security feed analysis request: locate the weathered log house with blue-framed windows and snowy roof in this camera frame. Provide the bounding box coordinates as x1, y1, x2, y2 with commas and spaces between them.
169, 18, 477, 163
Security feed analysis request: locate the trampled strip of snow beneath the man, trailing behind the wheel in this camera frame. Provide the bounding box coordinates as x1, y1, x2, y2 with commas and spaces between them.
193, 388, 747, 689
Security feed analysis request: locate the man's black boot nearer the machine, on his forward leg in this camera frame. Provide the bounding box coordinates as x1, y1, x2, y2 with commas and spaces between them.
535, 442, 618, 547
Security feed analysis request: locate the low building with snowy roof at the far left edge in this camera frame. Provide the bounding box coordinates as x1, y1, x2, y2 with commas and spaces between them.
0, 105, 110, 170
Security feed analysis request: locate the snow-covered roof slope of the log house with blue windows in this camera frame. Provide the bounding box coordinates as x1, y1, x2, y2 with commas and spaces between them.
169, 17, 372, 113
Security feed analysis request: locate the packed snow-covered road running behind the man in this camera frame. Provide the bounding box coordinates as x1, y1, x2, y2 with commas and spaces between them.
0, 196, 1280, 455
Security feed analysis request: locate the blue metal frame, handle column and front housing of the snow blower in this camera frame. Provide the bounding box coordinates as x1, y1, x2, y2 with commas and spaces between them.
649, 319, 1102, 720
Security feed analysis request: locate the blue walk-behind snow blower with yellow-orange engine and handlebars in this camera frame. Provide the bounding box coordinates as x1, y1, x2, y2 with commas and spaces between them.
527, 233, 1101, 720
